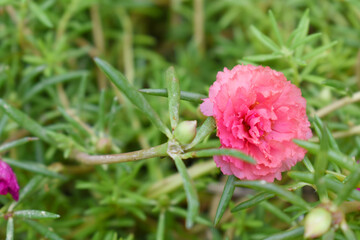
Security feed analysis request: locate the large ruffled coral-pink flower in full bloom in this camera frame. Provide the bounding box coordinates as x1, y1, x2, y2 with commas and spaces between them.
200, 65, 312, 182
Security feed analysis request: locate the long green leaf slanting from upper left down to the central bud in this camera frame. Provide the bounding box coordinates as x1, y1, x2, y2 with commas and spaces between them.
95, 58, 172, 138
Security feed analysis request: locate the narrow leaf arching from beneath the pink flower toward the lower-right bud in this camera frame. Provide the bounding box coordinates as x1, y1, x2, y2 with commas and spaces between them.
235, 181, 310, 209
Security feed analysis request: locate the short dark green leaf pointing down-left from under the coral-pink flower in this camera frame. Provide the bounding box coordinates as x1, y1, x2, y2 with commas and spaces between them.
214, 175, 236, 225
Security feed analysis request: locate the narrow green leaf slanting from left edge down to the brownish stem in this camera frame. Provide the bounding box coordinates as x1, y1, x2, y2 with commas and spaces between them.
0, 98, 53, 143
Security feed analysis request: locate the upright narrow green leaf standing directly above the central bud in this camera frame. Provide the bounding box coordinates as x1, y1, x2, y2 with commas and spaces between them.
166, 67, 180, 131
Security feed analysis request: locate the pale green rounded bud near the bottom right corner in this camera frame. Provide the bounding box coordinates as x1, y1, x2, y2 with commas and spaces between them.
304, 207, 331, 238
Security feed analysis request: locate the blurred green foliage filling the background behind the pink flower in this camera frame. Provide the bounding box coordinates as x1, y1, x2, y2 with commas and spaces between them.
0, 0, 360, 240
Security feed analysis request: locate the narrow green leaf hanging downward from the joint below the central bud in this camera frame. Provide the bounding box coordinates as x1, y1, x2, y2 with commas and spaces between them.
170, 154, 199, 228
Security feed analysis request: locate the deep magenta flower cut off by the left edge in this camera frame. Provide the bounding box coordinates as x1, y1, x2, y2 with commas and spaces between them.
0, 159, 20, 201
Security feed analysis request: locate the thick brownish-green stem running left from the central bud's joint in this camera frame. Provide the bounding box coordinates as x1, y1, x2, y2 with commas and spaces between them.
70, 143, 168, 165
